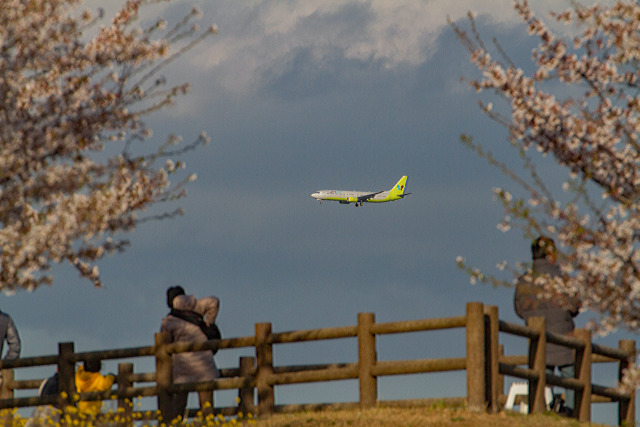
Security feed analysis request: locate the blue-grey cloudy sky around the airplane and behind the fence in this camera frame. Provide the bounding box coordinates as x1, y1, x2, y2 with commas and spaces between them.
5, 0, 629, 423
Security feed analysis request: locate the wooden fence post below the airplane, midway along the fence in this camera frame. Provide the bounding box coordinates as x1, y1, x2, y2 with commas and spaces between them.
358, 313, 378, 408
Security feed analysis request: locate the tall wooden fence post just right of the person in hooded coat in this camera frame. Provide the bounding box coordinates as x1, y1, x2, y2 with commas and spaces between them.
255, 323, 275, 415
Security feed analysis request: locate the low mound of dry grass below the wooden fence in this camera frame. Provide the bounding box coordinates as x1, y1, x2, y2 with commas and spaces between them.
255, 407, 598, 427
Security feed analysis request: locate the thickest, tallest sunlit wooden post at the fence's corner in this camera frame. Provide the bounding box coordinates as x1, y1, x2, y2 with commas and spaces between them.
466, 302, 486, 412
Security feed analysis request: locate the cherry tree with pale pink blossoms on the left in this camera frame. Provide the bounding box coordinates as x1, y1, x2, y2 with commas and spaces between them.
0, 0, 215, 291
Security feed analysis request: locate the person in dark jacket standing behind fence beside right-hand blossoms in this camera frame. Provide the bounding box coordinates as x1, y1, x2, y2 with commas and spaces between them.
514, 236, 580, 416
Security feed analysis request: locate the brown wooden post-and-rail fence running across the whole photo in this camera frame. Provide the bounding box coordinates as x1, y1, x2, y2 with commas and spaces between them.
0, 303, 636, 425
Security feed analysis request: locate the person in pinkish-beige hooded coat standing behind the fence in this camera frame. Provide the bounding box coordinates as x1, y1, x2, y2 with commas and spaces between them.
160, 288, 220, 423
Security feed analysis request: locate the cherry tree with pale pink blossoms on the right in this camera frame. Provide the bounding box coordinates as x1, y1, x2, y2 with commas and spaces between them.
452, 1, 640, 342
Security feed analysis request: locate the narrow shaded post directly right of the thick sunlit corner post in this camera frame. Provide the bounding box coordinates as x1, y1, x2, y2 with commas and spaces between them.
484, 305, 499, 413
